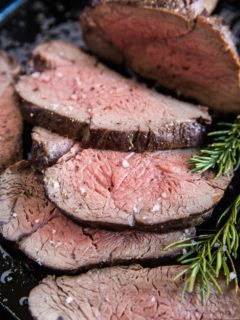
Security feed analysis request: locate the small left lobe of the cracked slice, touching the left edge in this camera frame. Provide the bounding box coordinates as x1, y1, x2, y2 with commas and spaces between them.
0, 161, 56, 234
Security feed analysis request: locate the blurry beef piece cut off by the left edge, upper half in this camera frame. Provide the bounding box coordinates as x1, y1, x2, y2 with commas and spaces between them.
0, 50, 22, 172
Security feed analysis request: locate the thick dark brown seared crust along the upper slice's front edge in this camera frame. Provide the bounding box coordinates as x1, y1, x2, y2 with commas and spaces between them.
19, 101, 209, 152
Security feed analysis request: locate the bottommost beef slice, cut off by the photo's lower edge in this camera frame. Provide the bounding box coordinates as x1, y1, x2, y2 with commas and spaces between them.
28, 266, 239, 320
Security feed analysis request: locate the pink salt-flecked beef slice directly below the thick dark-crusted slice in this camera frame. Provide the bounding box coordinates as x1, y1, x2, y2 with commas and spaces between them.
44, 145, 231, 232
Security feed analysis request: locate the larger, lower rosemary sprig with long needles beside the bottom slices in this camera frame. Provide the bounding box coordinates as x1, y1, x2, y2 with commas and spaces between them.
165, 195, 240, 304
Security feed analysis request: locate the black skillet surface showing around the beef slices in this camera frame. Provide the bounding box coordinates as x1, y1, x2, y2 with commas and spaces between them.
0, 0, 240, 320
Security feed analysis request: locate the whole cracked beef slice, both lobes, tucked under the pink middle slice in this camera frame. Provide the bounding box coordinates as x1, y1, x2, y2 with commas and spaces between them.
0, 161, 195, 272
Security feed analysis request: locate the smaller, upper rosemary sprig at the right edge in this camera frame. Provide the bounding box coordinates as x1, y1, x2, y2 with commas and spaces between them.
190, 116, 240, 176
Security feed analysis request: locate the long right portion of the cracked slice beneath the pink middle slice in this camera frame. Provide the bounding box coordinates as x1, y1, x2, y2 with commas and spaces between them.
19, 215, 195, 272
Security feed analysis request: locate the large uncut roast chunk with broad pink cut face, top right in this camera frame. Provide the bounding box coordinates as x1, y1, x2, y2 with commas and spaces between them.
80, 0, 240, 113
